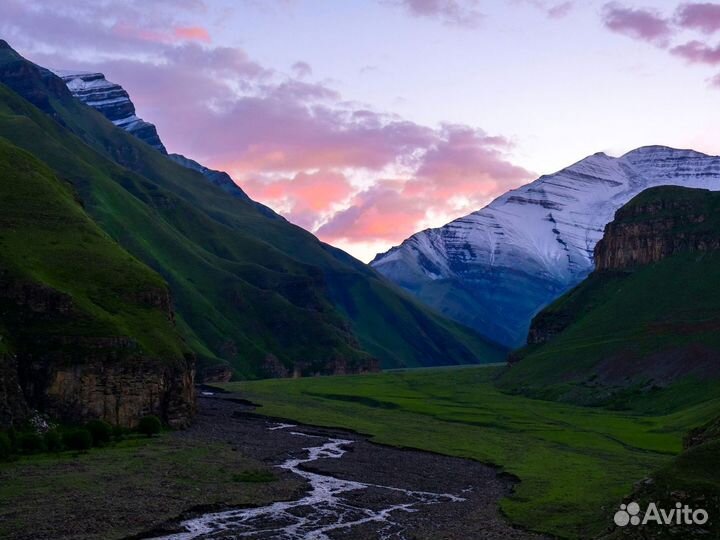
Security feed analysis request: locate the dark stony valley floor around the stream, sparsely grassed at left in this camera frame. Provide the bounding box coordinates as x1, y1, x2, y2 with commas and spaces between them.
0, 394, 537, 540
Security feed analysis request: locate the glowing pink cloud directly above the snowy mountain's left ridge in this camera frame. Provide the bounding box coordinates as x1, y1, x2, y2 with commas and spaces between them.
317, 125, 535, 243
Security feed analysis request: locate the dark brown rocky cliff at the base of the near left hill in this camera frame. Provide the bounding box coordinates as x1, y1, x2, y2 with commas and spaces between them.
0, 272, 195, 427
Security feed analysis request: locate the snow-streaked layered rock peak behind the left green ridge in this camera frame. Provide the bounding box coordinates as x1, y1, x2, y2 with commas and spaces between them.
55, 70, 167, 154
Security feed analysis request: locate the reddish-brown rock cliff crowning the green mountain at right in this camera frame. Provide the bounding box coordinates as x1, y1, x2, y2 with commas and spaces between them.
595, 189, 720, 271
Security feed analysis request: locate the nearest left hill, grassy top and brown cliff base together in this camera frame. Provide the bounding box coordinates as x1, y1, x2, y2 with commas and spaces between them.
0, 138, 194, 427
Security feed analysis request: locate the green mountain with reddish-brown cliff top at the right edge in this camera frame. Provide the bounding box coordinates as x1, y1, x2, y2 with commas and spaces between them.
501, 186, 720, 413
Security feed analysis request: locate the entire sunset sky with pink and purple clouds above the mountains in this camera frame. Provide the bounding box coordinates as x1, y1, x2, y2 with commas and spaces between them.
0, 0, 720, 261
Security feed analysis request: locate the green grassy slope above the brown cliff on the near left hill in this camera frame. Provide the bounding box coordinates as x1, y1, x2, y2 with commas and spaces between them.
0, 138, 187, 361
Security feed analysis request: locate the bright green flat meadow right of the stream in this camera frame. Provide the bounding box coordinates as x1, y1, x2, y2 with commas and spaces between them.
224, 367, 720, 538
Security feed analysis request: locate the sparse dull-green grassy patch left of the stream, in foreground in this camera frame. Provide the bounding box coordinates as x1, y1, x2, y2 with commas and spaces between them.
0, 432, 303, 540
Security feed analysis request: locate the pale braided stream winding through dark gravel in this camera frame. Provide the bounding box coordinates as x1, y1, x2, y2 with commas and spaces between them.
155, 424, 464, 540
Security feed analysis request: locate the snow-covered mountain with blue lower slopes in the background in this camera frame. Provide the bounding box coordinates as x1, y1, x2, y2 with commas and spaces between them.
371, 146, 720, 347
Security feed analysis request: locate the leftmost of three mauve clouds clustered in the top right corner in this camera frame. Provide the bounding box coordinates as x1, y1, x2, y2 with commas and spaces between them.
603, 2, 672, 47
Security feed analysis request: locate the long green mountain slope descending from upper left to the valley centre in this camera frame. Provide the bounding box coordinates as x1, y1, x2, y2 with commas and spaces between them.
0, 42, 505, 379
